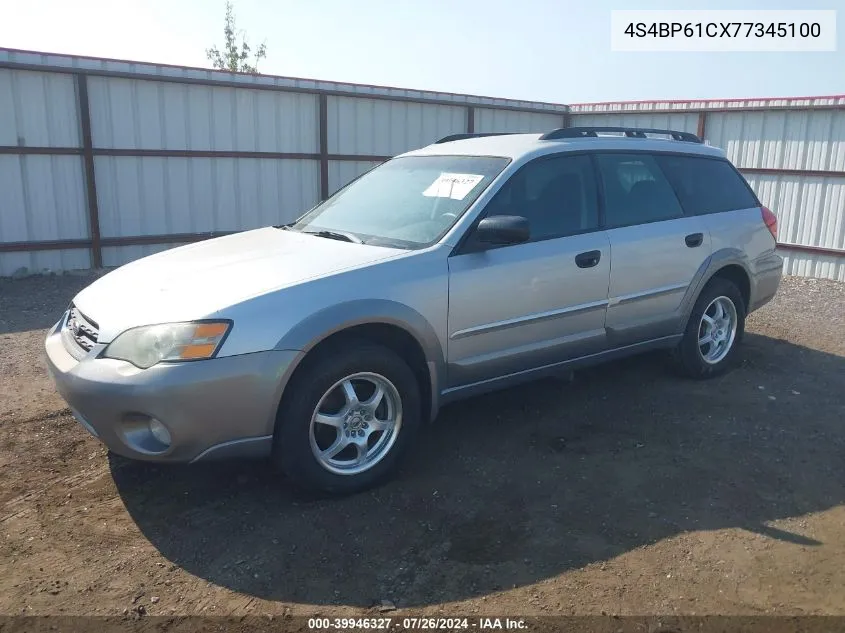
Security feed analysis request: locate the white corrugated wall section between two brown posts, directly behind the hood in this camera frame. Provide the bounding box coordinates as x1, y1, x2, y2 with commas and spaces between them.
88, 77, 320, 266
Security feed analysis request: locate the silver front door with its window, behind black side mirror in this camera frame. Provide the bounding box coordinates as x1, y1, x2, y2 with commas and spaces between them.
448, 155, 610, 388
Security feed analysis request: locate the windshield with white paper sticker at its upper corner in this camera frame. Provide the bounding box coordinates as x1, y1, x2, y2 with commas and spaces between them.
289, 156, 509, 248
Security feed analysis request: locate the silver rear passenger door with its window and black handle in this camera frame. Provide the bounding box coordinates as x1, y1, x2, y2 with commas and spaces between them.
596, 153, 711, 347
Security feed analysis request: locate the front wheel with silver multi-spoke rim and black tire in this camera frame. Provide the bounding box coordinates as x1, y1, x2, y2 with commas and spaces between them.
273, 341, 421, 494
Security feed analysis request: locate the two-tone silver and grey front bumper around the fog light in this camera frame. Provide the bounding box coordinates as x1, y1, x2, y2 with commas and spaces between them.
45, 322, 302, 462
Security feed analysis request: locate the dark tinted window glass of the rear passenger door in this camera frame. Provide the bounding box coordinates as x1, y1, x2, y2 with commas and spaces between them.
596, 154, 684, 228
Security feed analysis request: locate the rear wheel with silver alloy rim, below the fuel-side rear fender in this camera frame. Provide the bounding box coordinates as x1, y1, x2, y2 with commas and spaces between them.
673, 277, 745, 379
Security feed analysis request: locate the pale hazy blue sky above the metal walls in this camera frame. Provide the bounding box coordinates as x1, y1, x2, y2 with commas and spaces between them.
0, 0, 845, 103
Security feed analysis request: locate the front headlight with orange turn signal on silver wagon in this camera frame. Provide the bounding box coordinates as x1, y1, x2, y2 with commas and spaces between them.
103, 321, 232, 369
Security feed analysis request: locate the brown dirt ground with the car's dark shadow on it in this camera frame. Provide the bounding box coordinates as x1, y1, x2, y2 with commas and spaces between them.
0, 276, 845, 616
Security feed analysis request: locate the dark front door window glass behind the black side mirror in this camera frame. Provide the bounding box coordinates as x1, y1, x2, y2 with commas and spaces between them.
485, 155, 599, 242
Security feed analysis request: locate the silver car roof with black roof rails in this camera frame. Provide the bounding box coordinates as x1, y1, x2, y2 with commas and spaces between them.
401, 133, 725, 160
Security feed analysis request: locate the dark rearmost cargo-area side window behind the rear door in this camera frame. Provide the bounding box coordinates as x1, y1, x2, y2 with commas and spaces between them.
656, 154, 757, 215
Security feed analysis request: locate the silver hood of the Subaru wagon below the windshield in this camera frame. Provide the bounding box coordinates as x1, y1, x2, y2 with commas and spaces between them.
73, 227, 403, 342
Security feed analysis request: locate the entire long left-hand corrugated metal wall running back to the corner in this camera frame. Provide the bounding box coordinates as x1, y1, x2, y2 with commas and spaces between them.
0, 49, 566, 275
